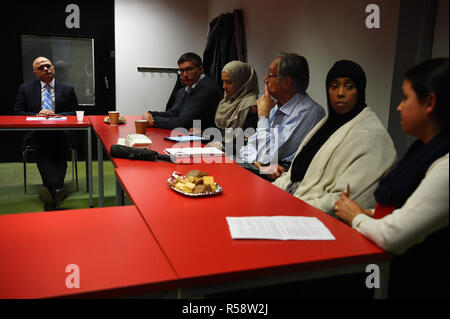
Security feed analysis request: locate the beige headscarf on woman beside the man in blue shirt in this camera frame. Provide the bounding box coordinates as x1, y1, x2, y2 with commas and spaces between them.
216, 61, 259, 130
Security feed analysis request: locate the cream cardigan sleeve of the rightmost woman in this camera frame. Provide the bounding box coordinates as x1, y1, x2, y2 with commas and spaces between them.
352, 153, 449, 254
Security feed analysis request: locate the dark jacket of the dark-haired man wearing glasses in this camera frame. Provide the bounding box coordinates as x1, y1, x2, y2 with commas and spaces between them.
151, 76, 223, 130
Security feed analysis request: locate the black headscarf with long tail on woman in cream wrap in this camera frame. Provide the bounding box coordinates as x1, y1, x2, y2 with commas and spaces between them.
291, 60, 367, 183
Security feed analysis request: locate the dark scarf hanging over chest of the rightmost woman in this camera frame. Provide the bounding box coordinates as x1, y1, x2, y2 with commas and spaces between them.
375, 130, 449, 208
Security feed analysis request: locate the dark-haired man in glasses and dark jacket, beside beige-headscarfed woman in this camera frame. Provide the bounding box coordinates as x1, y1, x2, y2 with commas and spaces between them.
142, 52, 223, 129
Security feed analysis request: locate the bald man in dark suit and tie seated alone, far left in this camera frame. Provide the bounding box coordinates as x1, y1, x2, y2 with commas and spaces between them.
14, 57, 78, 210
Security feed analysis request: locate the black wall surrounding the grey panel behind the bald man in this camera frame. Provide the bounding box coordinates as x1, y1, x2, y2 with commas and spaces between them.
0, 0, 116, 162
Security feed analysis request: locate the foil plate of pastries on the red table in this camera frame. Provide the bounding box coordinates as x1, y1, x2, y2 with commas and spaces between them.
167, 169, 222, 197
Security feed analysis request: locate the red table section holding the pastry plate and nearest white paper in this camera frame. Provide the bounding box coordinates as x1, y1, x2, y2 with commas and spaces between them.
116, 162, 390, 297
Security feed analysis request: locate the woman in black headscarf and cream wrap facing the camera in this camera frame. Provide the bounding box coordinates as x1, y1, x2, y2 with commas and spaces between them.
274, 60, 396, 214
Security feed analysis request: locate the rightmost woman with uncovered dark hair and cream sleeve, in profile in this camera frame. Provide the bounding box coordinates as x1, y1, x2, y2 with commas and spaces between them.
334, 58, 449, 298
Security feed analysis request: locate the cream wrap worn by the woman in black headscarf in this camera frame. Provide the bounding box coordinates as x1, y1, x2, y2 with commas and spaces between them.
274, 107, 397, 214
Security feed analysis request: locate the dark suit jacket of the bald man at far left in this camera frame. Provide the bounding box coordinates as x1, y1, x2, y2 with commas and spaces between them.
14, 80, 78, 115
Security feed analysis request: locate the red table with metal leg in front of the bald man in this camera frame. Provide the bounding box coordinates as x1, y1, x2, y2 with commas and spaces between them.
0, 115, 94, 207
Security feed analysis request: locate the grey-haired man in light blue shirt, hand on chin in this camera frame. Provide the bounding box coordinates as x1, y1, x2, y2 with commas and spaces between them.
239, 53, 325, 181
